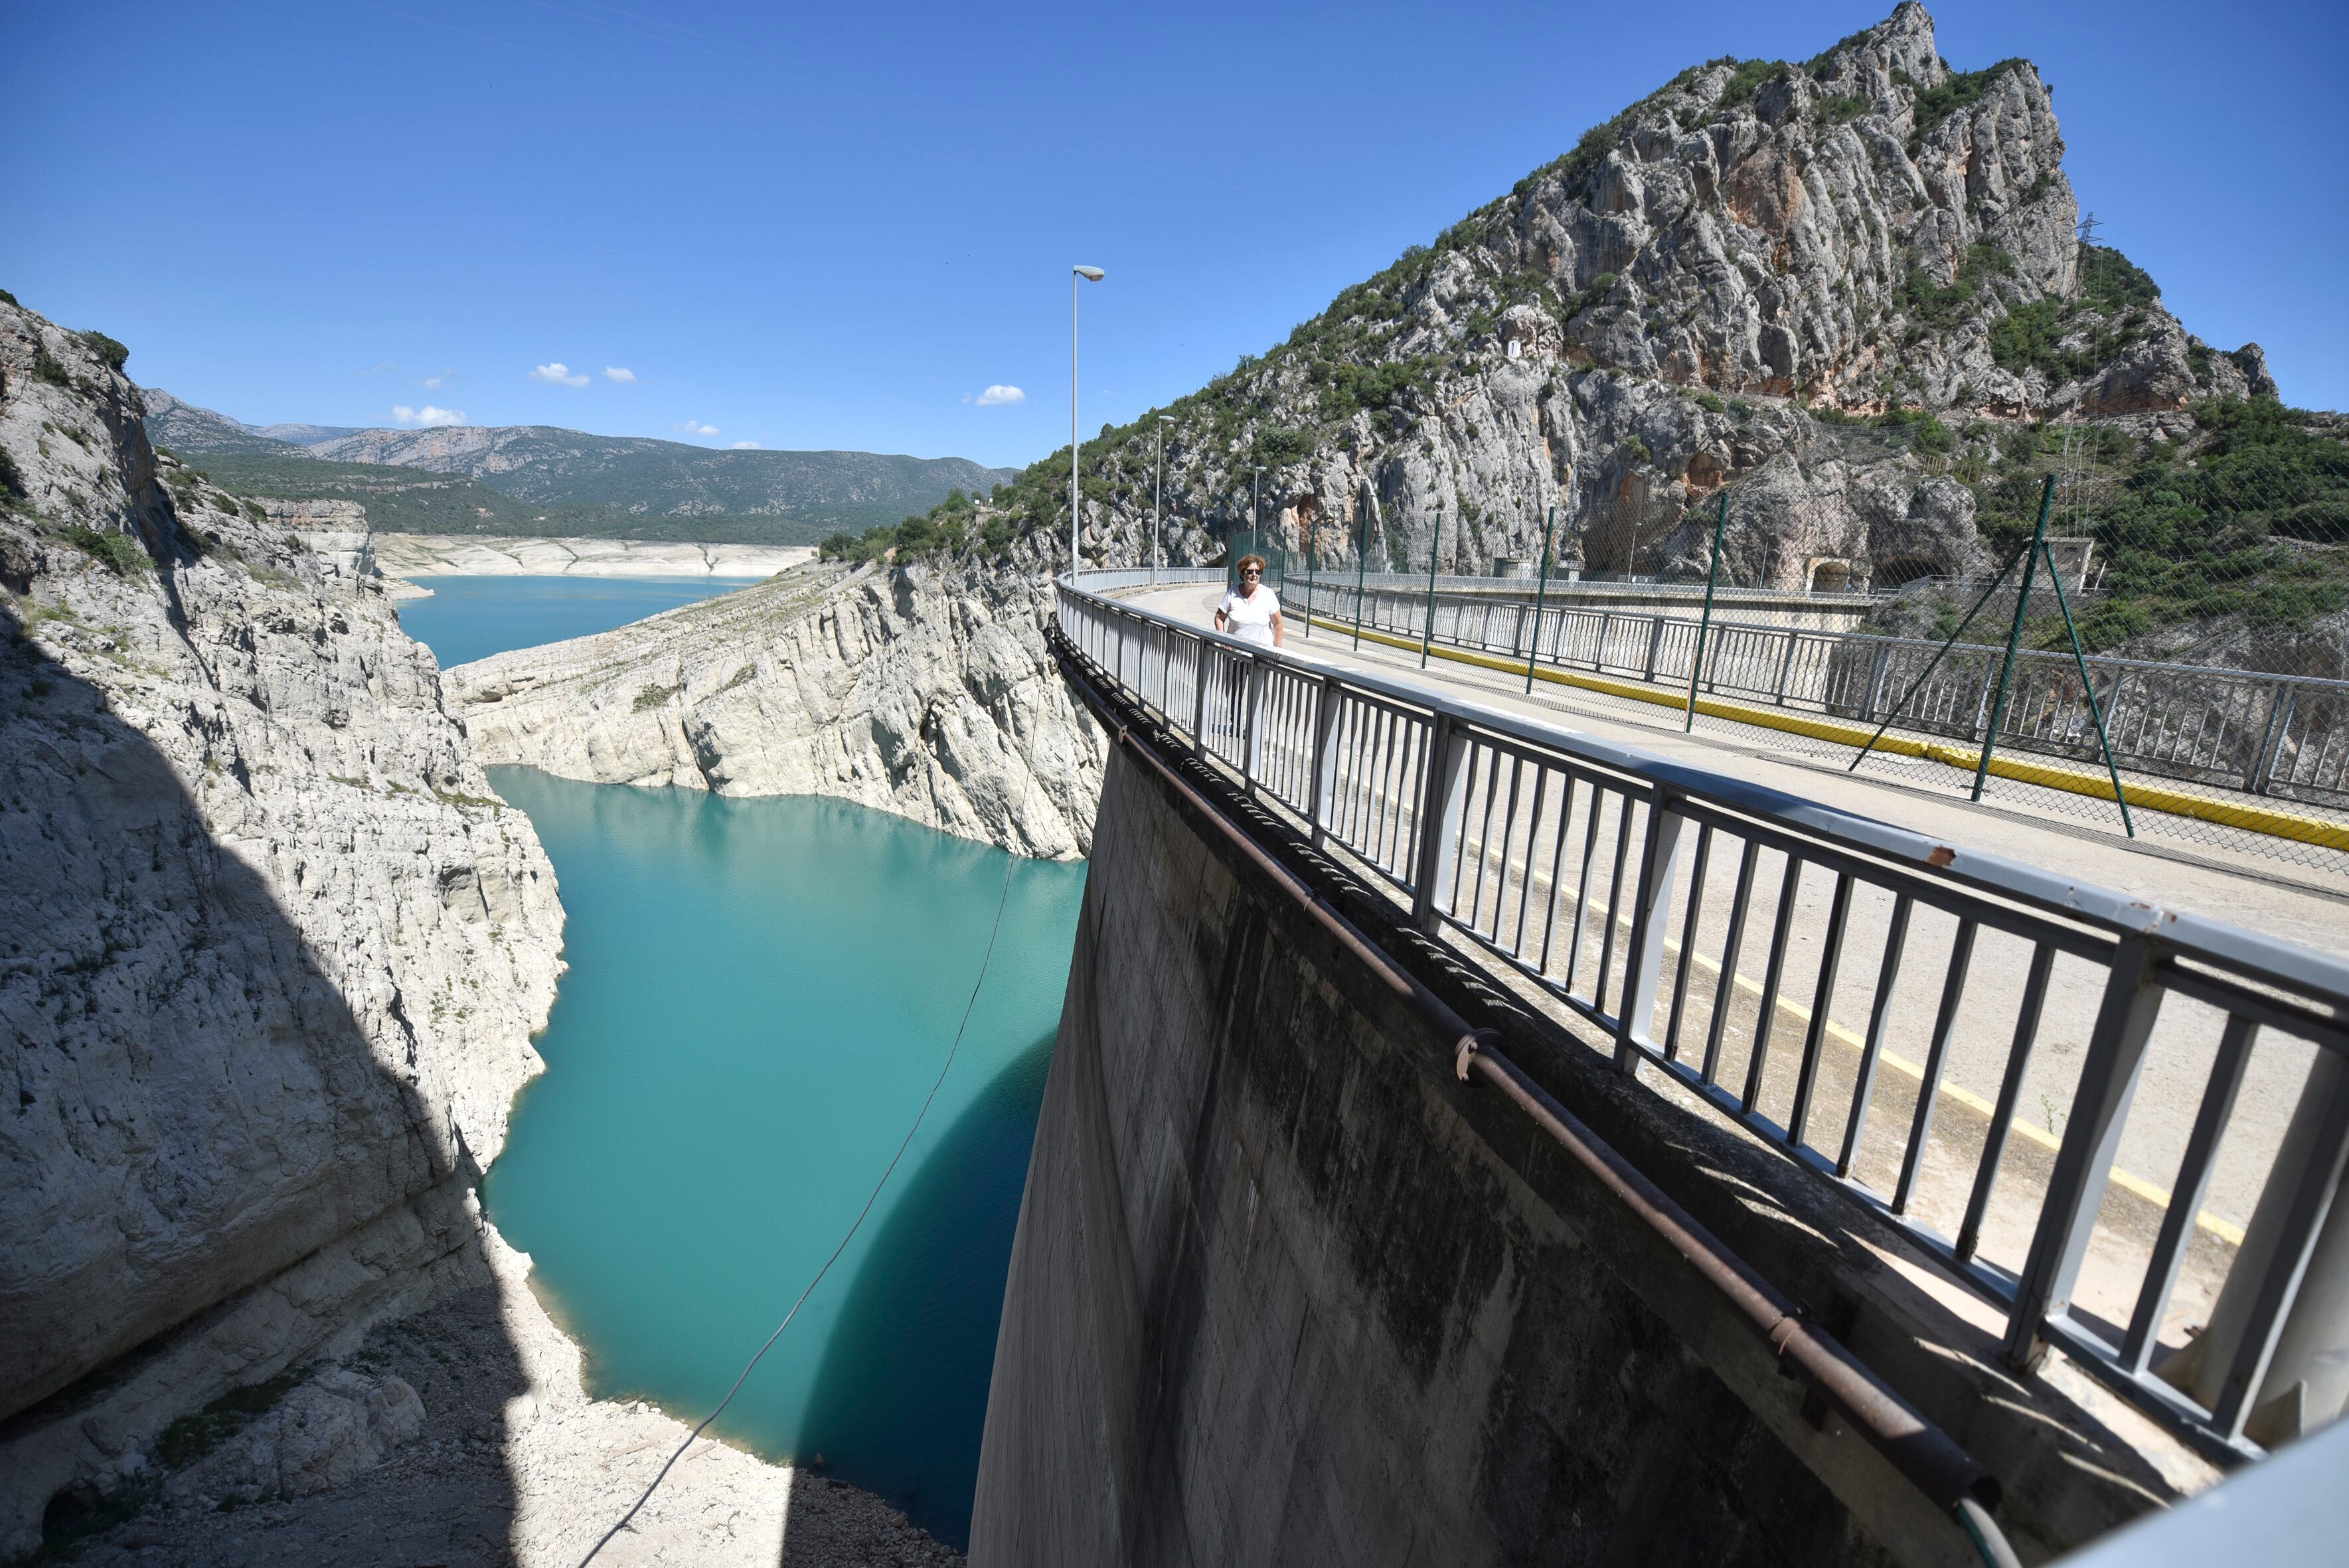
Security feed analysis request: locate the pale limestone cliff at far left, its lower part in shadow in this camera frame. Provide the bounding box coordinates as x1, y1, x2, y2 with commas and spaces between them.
0, 303, 562, 1554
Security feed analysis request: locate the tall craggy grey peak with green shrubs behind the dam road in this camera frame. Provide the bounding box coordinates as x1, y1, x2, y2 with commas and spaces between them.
975, 3, 2276, 589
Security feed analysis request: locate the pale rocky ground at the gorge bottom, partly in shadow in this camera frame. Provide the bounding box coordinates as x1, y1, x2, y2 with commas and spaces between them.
56, 1230, 963, 1568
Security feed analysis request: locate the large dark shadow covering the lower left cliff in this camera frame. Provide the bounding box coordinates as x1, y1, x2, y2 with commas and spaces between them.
0, 605, 526, 1568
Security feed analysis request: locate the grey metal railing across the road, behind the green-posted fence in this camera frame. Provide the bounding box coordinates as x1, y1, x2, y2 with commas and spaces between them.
1289, 582, 2349, 807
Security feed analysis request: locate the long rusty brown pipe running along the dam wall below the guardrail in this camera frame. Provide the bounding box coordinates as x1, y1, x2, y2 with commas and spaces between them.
1057, 619, 1999, 1539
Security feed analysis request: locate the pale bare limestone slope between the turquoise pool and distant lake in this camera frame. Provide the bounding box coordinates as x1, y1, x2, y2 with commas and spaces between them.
446, 566, 1106, 859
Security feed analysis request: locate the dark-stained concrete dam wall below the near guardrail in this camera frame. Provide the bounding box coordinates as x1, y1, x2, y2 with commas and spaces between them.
970, 746, 2168, 1568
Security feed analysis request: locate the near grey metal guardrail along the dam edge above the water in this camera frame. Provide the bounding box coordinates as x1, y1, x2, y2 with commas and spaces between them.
1060, 573, 2349, 1460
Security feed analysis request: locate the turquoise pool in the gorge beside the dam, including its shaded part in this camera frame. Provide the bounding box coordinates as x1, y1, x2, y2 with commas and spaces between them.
484, 767, 1086, 1547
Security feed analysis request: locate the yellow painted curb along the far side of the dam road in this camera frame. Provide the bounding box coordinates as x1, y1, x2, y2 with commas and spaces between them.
1313, 615, 2349, 850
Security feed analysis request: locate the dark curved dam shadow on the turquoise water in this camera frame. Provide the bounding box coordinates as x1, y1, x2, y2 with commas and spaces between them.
785, 1035, 1055, 1559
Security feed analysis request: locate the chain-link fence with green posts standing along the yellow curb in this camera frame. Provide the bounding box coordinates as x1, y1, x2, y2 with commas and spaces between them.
1289, 404, 2349, 871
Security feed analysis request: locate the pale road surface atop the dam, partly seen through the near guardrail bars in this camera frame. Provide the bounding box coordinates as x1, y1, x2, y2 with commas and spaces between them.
1121, 584, 2349, 1338
